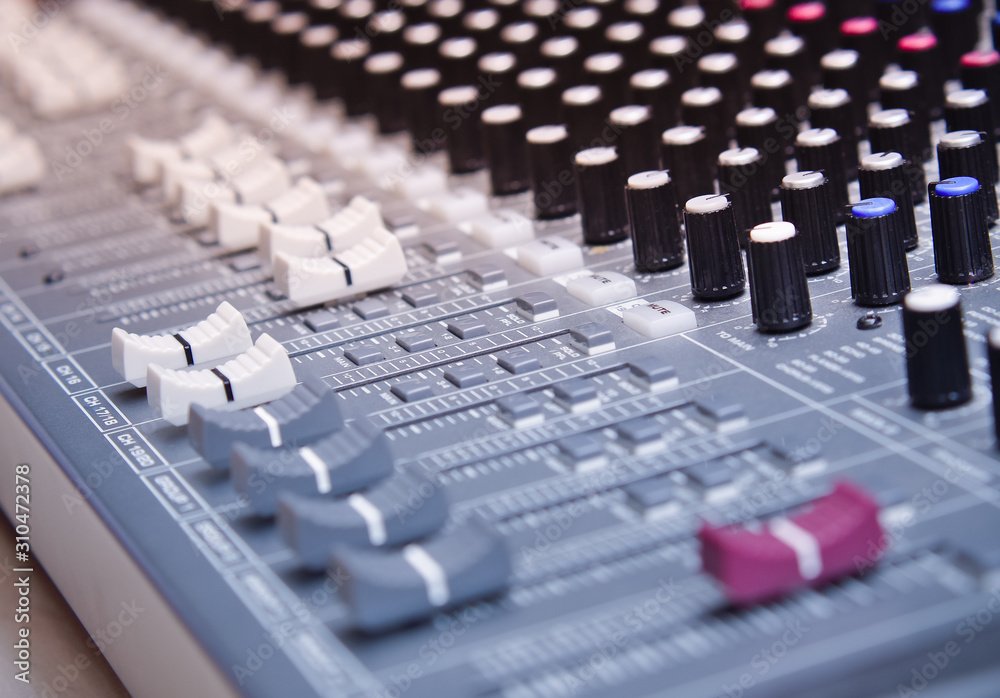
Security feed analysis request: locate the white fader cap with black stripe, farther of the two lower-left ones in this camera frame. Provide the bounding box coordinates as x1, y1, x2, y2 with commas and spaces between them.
111, 303, 253, 388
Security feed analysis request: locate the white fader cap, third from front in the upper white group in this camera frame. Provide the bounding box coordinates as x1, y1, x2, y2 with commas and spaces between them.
215, 177, 330, 250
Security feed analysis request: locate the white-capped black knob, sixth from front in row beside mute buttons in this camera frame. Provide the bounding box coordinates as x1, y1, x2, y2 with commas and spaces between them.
482, 104, 531, 196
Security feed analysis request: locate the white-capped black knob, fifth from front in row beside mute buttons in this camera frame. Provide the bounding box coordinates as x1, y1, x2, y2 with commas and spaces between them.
525, 124, 576, 220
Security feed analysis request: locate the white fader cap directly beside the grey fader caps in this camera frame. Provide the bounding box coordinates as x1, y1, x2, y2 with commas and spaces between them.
146, 334, 295, 426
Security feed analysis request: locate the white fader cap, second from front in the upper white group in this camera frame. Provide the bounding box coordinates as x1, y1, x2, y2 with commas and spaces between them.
260, 196, 385, 264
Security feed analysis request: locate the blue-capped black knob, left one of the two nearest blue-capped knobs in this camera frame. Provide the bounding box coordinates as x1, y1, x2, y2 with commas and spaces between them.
847, 197, 910, 306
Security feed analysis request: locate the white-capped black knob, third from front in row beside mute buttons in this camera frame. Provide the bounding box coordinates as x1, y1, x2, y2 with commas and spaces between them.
625, 170, 684, 273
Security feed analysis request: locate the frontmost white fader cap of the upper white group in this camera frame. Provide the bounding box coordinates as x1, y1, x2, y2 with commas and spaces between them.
274, 228, 407, 306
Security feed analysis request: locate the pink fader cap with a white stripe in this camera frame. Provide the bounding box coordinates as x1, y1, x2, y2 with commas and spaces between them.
699, 481, 885, 605
